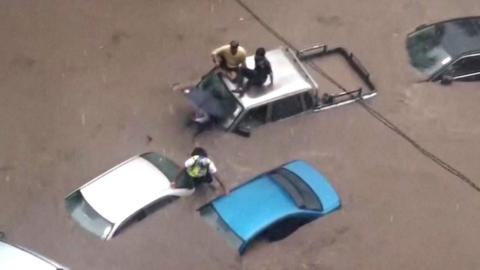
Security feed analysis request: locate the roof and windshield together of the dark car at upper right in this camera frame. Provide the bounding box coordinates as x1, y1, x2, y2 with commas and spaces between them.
407, 17, 480, 77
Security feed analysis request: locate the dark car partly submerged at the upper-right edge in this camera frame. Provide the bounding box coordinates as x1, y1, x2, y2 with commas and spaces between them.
407, 17, 480, 84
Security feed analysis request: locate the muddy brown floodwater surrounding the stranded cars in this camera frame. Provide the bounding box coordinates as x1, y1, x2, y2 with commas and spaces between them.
0, 0, 480, 270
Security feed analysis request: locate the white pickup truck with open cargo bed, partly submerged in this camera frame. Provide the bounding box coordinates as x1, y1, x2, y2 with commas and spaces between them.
185, 45, 377, 136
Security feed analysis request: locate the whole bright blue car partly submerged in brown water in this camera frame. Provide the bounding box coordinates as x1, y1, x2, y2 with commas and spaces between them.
199, 160, 341, 254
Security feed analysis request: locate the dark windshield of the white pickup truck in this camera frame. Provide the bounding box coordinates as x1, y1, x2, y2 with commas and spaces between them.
190, 74, 241, 128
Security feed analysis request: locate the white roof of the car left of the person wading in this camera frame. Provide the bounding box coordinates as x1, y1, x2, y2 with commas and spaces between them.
80, 156, 172, 224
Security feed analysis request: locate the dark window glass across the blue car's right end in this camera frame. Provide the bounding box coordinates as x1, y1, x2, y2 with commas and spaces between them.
270, 168, 322, 211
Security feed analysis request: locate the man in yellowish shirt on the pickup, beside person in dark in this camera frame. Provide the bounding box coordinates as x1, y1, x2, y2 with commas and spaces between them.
212, 40, 247, 73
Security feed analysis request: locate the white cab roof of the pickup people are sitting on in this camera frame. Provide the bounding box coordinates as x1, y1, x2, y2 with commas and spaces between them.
224, 48, 317, 109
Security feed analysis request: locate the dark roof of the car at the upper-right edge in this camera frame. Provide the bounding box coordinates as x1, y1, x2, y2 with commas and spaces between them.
427, 17, 480, 57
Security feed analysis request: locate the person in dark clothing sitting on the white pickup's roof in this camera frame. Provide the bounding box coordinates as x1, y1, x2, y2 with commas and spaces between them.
236, 48, 273, 95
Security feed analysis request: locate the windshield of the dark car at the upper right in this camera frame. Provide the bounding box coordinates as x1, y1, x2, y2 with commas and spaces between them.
407, 25, 452, 77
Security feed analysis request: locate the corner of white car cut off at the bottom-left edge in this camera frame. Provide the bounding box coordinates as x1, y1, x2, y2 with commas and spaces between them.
0, 233, 68, 270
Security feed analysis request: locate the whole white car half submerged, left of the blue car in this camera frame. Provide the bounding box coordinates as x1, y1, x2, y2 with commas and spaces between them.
65, 152, 195, 240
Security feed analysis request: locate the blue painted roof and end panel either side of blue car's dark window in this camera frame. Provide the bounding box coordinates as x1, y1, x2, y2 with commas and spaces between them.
211, 161, 340, 242
